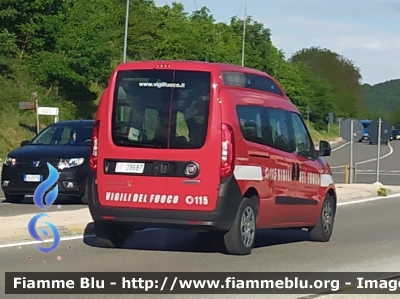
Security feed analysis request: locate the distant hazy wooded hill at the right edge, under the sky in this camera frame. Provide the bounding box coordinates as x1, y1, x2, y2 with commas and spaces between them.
362, 79, 400, 127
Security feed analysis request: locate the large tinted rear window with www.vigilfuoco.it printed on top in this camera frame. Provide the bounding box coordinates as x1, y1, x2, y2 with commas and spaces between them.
111, 70, 211, 149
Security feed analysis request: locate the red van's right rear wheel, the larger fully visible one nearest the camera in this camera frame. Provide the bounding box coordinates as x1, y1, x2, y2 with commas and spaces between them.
223, 196, 258, 255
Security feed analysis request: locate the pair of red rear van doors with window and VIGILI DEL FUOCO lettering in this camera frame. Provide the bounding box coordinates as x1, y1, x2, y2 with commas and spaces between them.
98, 68, 221, 211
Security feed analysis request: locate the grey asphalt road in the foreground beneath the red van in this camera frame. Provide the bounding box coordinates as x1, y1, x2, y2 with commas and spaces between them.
0, 198, 400, 299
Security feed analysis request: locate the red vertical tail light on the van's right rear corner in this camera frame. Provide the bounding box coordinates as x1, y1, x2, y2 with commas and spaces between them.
220, 124, 235, 178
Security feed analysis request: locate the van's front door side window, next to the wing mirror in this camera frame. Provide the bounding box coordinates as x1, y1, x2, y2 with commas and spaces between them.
290, 112, 315, 159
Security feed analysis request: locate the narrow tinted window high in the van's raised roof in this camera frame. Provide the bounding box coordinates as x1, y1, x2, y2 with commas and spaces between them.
222, 72, 284, 97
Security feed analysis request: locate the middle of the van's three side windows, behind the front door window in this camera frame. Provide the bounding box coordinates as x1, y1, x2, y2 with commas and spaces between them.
266, 108, 292, 153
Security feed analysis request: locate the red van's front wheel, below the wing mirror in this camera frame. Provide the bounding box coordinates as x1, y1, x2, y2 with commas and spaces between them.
309, 194, 336, 242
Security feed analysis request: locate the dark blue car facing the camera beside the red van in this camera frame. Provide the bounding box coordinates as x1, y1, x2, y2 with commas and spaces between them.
1, 120, 94, 203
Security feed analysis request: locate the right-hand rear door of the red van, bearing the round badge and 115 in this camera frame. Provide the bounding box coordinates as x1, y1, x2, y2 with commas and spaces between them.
167, 71, 222, 211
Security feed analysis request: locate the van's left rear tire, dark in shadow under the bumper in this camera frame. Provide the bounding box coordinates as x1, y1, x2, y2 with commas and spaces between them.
94, 221, 127, 248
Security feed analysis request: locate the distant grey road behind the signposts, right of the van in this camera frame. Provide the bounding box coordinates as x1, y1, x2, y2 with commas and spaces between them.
326, 141, 400, 186
